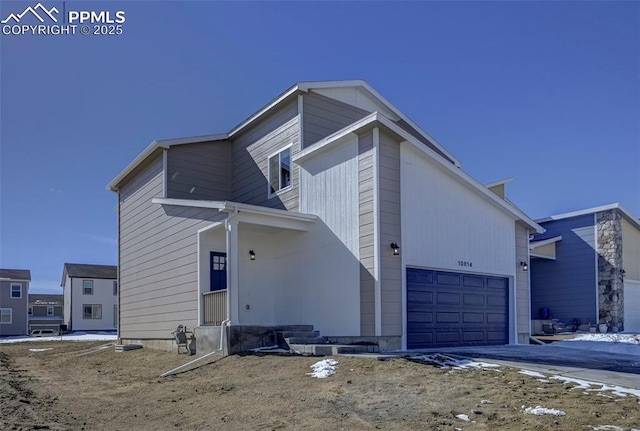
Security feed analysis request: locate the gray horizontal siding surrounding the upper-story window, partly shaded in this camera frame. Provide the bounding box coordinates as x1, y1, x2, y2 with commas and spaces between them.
231, 100, 300, 211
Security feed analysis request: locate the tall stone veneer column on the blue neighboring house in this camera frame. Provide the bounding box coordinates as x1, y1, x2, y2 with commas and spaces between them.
596, 210, 624, 332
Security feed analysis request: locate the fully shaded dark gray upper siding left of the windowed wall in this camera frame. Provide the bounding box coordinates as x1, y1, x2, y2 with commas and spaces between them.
166, 141, 231, 201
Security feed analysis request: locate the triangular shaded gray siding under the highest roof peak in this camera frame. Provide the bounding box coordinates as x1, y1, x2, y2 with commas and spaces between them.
302, 92, 370, 148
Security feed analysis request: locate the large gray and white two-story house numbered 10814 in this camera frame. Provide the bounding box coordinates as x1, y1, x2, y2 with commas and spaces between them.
108, 81, 543, 352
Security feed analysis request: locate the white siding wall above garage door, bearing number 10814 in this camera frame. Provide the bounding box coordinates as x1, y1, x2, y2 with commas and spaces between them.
400, 142, 516, 276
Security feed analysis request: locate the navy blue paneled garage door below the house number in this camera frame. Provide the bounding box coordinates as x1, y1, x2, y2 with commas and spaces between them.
407, 268, 509, 349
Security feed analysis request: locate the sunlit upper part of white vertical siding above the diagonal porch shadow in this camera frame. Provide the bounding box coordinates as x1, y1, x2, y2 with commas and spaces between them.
300, 135, 360, 256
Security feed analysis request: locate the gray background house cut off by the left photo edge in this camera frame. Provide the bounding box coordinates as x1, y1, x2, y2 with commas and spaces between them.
0, 269, 31, 336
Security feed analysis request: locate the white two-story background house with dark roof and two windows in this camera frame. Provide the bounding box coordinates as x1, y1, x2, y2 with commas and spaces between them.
61, 263, 118, 331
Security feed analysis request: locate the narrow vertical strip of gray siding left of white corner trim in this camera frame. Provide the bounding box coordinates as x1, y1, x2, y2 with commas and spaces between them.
358, 132, 376, 336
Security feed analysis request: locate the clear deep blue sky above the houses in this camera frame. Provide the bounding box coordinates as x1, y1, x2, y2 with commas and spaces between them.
0, 1, 640, 293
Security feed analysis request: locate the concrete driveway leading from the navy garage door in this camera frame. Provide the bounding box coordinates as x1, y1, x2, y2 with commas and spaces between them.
407, 344, 640, 389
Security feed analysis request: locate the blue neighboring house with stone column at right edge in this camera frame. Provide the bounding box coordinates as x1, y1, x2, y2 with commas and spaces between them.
530, 203, 640, 332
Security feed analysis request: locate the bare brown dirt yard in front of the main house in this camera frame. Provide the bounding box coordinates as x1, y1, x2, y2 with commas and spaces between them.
0, 342, 640, 431
